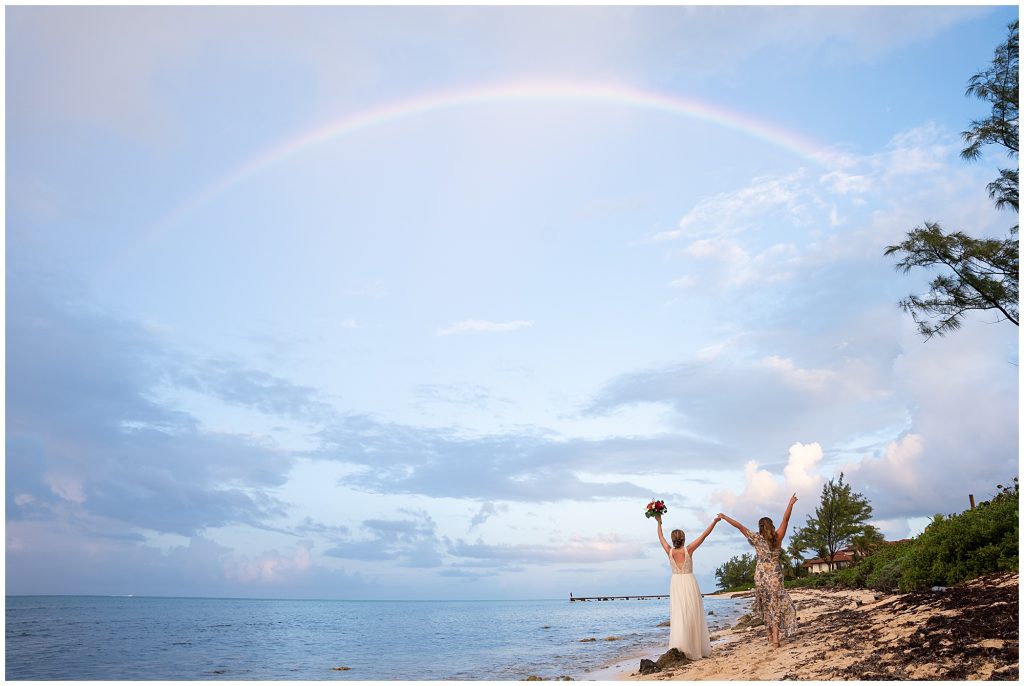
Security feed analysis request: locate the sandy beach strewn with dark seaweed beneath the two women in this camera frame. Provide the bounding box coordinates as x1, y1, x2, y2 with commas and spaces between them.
618, 573, 1019, 681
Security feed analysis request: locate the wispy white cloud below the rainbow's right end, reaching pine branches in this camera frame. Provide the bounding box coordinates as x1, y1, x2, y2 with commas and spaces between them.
654, 123, 1007, 298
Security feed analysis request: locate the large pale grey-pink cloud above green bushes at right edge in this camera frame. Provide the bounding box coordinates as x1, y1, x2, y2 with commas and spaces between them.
844, 317, 1020, 517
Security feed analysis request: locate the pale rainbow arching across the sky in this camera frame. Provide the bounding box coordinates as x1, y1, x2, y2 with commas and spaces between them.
150, 82, 830, 239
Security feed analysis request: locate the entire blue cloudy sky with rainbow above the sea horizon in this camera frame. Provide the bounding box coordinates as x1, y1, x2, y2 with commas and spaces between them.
5, 6, 1018, 598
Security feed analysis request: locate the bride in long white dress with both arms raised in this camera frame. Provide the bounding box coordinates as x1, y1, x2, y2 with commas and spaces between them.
654, 515, 721, 659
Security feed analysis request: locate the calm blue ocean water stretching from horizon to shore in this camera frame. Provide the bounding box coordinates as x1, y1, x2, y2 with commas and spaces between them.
5, 596, 749, 681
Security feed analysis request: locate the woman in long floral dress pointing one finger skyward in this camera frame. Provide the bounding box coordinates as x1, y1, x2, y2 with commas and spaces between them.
718, 494, 797, 648
